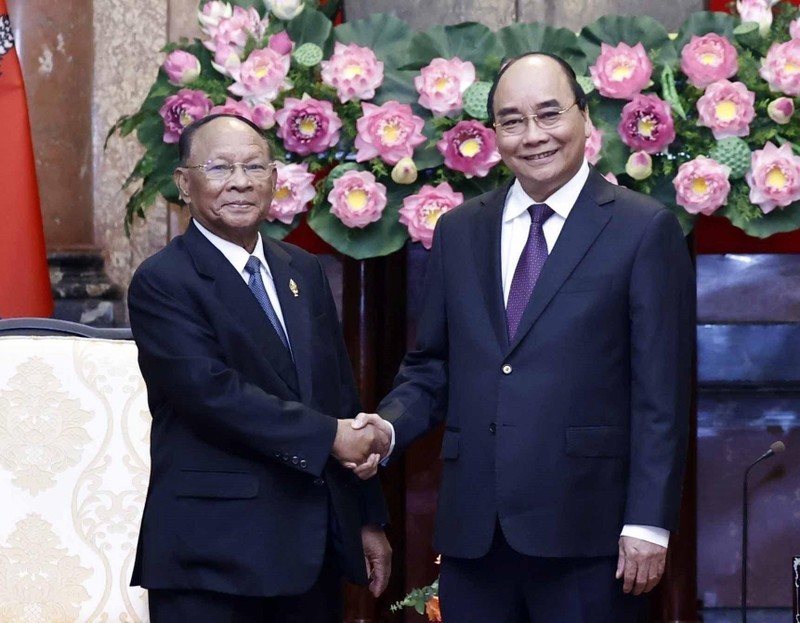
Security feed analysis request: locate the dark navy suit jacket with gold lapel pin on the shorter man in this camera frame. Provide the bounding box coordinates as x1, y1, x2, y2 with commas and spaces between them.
128, 225, 386, 596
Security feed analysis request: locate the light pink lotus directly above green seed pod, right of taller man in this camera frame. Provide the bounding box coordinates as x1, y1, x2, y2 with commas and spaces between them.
697, 80, 756, 140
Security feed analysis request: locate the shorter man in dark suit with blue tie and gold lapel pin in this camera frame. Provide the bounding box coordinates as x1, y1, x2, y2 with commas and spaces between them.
128, 115, 391, 623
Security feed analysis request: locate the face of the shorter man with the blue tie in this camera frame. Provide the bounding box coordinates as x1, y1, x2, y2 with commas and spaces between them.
175, 117, 275, 252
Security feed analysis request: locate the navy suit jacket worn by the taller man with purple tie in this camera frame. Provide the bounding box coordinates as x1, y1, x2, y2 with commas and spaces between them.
378, 171, 695, 558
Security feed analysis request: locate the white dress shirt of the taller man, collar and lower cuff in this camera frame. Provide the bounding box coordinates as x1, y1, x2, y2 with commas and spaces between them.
500, 160, 669, 547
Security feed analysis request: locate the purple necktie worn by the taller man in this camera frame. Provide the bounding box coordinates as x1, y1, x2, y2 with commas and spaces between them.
506, 203, 553, 341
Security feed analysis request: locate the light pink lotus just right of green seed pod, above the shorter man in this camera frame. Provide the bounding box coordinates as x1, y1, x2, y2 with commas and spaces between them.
320, 41, 383, 104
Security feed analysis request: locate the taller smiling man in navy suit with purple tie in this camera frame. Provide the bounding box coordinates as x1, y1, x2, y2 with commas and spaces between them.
359, 54, 695, 623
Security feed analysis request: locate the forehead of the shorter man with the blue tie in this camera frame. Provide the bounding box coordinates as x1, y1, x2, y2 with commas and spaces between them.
190, 117, 270, 161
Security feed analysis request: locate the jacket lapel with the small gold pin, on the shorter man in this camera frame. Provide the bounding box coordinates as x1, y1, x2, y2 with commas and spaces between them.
263, 237, 313, 403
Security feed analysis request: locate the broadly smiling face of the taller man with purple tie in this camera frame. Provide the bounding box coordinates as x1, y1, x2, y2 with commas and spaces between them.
493, 55, 591, 201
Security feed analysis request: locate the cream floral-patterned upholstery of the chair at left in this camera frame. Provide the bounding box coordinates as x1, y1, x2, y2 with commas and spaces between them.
0, 336, 150, 623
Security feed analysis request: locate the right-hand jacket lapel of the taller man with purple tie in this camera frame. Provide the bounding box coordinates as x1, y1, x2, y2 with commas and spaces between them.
510, 169, 614, 350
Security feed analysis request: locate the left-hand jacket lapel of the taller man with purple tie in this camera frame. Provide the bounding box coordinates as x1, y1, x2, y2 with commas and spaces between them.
472, 180, 513, 348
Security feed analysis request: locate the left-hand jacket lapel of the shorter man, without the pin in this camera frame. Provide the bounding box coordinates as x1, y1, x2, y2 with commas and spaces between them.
183, 224, 298, 394
